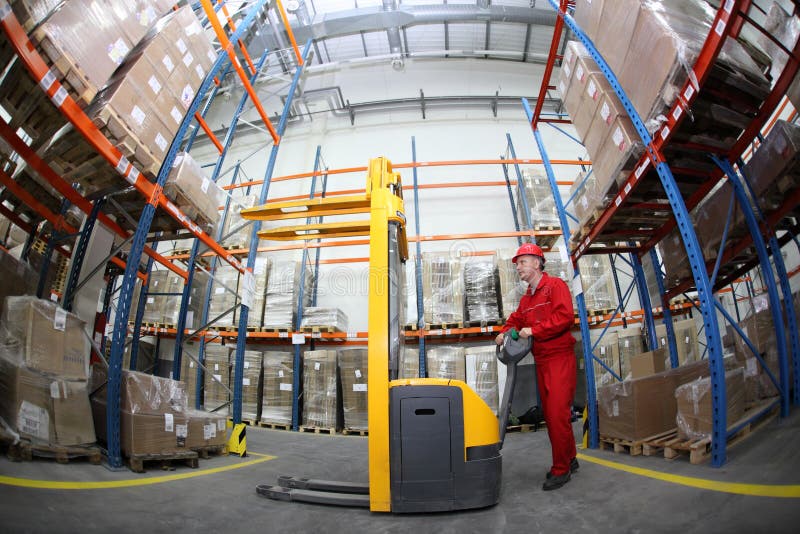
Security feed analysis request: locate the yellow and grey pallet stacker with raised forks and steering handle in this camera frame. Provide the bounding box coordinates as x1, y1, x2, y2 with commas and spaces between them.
247, 157, 530, 513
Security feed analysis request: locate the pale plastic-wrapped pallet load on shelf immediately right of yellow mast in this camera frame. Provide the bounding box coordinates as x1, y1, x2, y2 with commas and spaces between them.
422, 252, 464, 324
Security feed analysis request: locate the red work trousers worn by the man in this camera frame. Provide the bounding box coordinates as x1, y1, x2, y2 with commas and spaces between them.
536, 351, 577, 475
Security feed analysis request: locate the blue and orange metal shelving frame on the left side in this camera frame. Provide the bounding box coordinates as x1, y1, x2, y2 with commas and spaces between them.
0, 0, 308, 467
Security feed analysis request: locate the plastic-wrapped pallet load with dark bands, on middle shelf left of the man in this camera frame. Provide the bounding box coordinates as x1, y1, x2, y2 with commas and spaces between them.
462, 254, 500, 324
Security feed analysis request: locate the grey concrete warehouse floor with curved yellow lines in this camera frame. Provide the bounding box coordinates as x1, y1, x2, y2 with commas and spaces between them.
0, 409, 800, 534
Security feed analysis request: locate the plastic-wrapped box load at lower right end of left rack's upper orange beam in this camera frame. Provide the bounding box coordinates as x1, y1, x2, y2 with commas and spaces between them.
164, 152, 225, 233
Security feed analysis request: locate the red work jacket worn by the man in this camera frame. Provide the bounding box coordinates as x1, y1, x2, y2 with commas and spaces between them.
502, 272, 575, 360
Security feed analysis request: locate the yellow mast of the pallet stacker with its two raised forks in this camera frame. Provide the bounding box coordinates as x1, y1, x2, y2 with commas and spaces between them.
242, 157, 408, 512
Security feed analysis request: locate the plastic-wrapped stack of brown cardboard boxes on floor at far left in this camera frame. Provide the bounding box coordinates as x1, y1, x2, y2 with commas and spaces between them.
0, 296, 95, 446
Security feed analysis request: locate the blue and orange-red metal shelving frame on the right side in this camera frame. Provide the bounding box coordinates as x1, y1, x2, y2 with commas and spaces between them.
524, 0, 800, 467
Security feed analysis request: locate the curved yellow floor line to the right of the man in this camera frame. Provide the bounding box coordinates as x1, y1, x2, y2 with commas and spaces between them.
578, 453, 800, 499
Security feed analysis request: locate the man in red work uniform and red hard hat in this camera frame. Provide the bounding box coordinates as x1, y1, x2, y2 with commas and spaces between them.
495, 243, 579, 491
